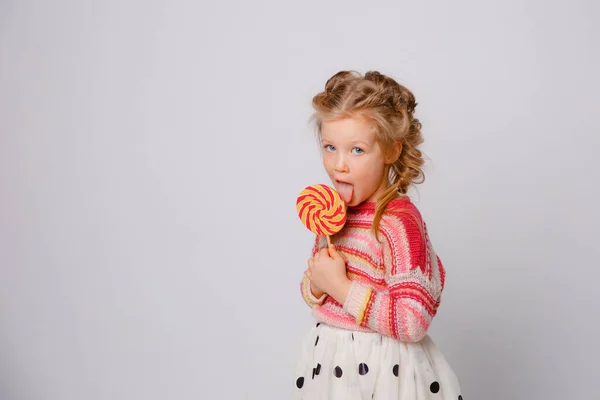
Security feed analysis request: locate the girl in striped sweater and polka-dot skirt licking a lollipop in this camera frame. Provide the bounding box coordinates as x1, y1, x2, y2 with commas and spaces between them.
292, 71, 462, 400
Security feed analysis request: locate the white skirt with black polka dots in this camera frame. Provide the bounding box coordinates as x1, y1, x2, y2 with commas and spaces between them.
291, 323, 463, 400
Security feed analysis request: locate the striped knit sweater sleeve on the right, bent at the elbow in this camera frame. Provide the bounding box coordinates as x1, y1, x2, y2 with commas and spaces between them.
344, 213, 444, 342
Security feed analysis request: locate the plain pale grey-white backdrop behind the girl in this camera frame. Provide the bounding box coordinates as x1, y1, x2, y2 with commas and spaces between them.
0, 0, 600, 400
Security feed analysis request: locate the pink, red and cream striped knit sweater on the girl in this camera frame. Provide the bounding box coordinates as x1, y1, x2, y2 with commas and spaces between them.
301, 197, 445, 342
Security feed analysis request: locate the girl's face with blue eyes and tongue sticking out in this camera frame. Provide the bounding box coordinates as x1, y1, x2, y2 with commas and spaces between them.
321, 118, 395, 207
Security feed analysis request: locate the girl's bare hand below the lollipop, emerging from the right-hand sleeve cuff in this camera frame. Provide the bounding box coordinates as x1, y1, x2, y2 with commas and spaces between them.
305, 244, 351, 305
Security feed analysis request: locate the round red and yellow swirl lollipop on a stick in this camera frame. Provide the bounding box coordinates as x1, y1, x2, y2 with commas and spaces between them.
296, 185, 346, 244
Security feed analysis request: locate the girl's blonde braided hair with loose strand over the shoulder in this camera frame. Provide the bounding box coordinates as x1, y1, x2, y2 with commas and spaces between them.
312, 71, 425, 237
